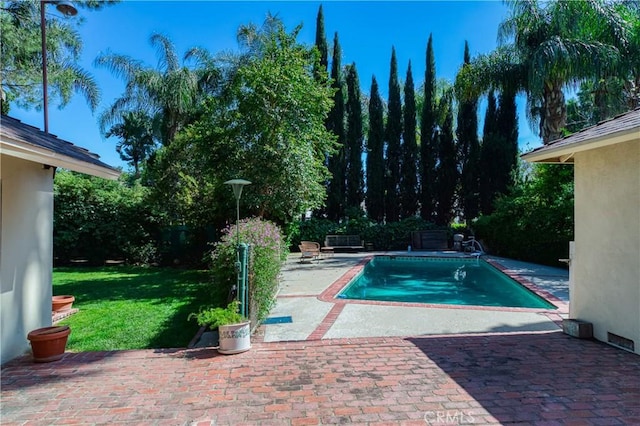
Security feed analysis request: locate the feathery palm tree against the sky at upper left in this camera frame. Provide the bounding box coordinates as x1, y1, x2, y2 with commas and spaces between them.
95, 34, 213, 146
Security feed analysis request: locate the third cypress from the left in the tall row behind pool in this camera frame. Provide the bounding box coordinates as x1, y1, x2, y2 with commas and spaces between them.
346, 62, 364, 209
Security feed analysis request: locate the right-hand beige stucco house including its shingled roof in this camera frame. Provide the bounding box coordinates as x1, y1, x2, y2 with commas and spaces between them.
522, 108, 640, 354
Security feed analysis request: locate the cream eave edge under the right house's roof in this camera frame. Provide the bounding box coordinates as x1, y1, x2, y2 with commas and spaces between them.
521, 127, 640, 164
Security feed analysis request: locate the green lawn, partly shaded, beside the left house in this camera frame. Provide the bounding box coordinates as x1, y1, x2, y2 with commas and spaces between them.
53, 266, 216, 351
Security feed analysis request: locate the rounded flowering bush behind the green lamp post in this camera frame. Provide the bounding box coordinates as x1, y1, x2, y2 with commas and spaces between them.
211, 218, 288, 324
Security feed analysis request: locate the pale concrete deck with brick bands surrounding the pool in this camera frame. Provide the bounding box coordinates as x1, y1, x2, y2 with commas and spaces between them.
259, 252, 569, 342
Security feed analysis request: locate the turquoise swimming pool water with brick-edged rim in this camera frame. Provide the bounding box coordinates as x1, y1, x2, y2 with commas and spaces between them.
337, 256, 556, 309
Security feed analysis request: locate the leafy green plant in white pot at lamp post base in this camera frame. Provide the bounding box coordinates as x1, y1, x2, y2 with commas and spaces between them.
189, 300, 251, 355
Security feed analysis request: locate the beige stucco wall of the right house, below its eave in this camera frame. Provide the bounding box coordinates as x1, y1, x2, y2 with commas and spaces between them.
570, 138, 640, 354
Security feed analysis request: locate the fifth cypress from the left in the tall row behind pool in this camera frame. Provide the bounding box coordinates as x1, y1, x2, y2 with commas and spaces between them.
384, 47, 402, 222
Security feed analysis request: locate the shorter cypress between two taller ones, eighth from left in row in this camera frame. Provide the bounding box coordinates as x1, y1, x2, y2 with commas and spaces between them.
435, 92, 458, 225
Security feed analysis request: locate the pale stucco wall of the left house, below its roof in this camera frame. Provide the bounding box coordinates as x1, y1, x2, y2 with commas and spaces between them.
0, 155, 53, 363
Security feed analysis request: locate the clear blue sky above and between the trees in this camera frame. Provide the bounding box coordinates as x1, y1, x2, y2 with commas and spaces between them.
10, 0, 541, 168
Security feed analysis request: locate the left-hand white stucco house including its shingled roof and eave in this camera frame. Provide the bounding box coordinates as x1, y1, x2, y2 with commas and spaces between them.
0, 115, 120, 363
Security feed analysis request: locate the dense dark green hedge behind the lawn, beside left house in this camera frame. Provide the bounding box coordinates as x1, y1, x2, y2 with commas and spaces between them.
53, 170, 159, 264
